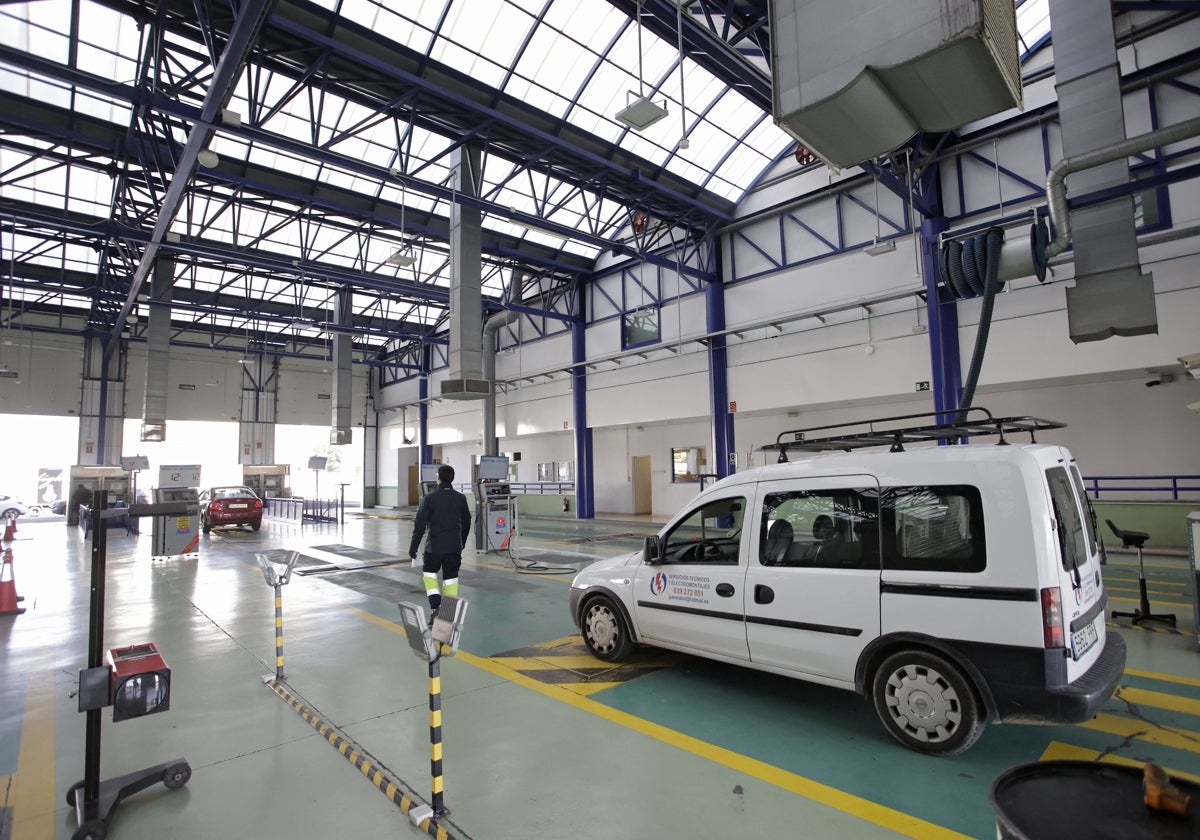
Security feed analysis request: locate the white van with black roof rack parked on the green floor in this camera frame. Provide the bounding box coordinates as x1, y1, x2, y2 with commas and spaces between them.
570, 408, 1126, 755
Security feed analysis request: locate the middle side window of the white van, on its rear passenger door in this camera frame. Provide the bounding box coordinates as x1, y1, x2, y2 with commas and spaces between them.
758, 488, 880, 569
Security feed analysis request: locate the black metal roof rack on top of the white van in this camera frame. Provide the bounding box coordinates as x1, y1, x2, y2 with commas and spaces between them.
762, 406, 1067, 463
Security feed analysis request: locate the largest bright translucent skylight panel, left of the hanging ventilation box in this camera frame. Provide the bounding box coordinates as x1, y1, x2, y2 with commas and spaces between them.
350, 0, 792, 207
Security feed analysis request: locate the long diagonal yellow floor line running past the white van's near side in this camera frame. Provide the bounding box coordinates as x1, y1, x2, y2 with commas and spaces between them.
346, 607, 967, 840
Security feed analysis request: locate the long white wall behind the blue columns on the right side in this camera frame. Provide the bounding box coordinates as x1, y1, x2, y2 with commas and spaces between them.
367, 22, 1200, 516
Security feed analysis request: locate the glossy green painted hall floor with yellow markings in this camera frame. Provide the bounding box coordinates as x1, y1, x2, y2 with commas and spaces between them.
0, 515, 1200, 840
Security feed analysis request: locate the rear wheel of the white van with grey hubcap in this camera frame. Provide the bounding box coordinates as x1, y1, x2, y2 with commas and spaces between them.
872, 650, 984, 755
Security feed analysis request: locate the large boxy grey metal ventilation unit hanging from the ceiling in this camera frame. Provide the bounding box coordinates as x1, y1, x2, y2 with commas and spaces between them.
770, 0, 1022, 167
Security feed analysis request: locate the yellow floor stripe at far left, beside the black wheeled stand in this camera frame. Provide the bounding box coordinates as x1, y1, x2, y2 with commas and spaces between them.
8, 667, 58, 840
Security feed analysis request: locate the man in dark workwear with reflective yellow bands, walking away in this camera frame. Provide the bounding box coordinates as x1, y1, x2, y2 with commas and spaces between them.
408, 464, 470, 613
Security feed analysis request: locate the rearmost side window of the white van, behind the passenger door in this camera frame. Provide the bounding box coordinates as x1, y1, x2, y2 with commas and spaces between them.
881, 485, 988, 572
